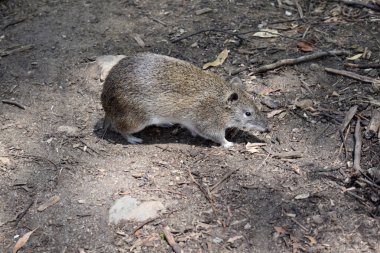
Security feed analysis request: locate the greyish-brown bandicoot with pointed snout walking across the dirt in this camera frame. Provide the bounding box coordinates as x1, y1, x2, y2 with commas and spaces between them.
101, 53, 268, 147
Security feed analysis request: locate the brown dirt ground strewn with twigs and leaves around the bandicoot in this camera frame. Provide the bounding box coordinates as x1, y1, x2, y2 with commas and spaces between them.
0, 0, 380, 253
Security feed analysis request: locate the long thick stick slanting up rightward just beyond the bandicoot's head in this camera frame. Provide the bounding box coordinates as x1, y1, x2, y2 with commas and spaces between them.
254, 50, 348, 73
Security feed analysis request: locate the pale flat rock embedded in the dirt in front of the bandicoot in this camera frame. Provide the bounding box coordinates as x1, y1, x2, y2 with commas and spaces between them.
108, 196, 165, 224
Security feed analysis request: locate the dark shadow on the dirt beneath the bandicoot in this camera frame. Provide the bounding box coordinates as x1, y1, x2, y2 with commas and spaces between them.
94, 119, 263, 147
